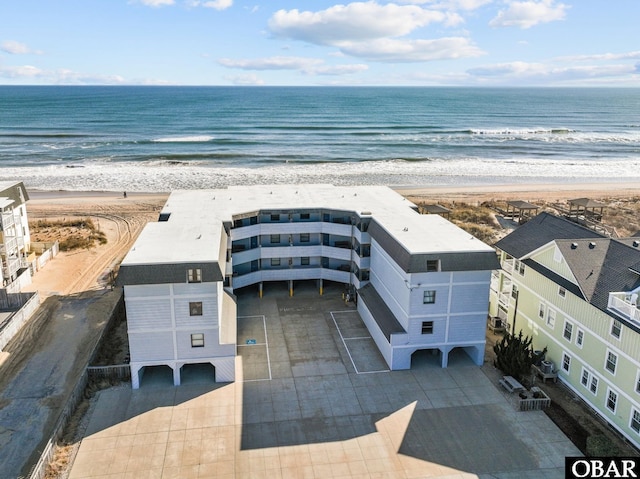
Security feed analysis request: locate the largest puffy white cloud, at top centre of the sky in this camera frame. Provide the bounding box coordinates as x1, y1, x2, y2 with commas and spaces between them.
269, 1, 463, 45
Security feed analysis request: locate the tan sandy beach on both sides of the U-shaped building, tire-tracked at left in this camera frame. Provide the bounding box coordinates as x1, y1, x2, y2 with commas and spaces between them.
22, 182, 640, 297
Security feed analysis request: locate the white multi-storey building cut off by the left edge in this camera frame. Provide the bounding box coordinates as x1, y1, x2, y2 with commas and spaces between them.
0, 181, 31, 287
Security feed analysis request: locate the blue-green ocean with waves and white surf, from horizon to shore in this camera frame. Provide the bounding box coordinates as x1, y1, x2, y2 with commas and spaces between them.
0, 86, 640, 192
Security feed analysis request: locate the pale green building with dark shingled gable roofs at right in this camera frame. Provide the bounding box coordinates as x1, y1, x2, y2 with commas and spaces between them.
491, 213, 640, 447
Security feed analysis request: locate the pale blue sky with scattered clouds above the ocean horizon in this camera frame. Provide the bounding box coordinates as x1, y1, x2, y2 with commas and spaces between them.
0, 0, 640, 87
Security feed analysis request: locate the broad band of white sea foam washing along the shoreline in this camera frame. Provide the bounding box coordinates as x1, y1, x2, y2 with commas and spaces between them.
7, 158, 640, 192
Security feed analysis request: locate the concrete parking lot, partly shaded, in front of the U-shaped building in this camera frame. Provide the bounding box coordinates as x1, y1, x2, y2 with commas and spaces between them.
70, 284, 580, 479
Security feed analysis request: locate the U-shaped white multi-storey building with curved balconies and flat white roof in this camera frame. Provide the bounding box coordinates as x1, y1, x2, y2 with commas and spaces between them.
118, 185, 499, 388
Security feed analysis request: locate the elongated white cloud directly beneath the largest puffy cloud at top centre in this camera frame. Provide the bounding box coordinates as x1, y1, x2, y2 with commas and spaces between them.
341, 37, 484, 63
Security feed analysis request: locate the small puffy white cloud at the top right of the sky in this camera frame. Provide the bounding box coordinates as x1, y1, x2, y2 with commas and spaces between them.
489, 0, 570, 29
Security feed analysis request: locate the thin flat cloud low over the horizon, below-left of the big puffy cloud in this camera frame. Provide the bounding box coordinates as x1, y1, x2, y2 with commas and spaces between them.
218, 57, 369, 75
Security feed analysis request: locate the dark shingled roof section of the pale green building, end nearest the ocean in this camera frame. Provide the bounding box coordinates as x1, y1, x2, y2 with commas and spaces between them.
494, 212, 604, 258
